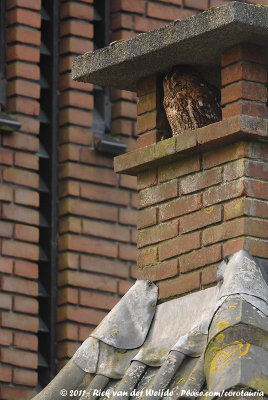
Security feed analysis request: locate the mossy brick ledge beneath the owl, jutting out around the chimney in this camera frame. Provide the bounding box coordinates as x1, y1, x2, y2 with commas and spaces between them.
114, 115, 268, 175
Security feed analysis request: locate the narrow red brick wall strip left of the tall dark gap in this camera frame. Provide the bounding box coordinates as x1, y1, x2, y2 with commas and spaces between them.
0, 0, 41, 399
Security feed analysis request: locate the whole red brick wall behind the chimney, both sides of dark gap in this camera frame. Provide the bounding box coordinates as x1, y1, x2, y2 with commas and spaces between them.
0, 0, 268, 400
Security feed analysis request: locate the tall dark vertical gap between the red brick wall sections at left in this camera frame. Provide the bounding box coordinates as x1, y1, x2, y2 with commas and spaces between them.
38, 0, 59, 387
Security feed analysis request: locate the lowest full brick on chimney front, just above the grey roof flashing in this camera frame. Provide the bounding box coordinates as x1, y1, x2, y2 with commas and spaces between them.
158, 271, 200, 299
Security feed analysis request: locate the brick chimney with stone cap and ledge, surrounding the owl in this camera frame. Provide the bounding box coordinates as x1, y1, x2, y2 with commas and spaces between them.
74, 2, 268, 302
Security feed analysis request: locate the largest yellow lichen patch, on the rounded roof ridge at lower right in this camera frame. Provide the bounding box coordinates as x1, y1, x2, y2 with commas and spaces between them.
209, 340, 250, 375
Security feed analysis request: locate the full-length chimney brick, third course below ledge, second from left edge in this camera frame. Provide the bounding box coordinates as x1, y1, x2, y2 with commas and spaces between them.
159, 194, 201, 221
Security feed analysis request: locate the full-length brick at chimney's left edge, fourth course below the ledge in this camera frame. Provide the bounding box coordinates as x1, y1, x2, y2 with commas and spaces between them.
137, 221, 179, 248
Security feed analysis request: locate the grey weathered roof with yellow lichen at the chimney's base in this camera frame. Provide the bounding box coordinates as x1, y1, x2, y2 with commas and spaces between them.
34, 250, 268, 400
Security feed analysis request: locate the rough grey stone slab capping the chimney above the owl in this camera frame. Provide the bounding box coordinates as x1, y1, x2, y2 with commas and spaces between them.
72, 1, 268, 91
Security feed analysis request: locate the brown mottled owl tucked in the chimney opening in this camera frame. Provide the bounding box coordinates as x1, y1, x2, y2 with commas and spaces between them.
163, 66, 221, 136
